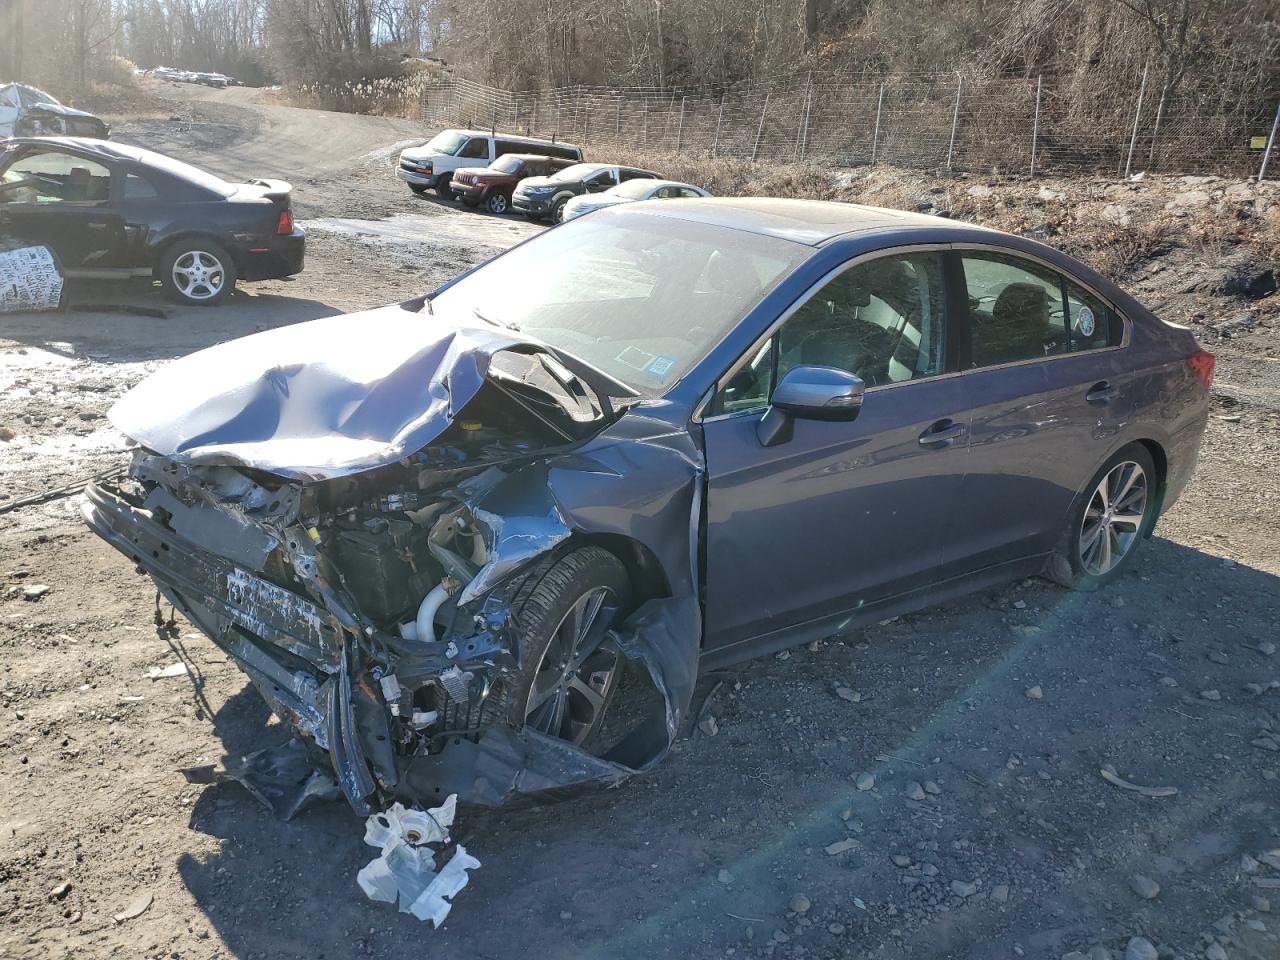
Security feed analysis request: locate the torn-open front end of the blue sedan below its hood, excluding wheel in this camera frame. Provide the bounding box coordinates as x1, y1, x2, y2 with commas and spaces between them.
86, 309, 700, 815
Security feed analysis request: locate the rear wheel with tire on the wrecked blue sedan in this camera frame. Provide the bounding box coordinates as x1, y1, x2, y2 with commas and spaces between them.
1048, 443, 1160, 591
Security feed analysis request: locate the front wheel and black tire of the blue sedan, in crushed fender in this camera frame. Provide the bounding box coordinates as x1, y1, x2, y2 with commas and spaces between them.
507, 547, 631, 745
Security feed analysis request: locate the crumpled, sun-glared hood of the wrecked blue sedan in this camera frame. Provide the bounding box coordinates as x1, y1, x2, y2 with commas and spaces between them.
110, 305, 540, 480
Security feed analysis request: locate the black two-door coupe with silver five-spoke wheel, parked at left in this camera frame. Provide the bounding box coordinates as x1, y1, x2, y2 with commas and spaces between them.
0, 137, 306, 306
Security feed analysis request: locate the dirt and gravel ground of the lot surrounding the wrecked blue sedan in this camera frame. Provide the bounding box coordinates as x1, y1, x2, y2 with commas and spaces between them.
0, 82, 1280, 960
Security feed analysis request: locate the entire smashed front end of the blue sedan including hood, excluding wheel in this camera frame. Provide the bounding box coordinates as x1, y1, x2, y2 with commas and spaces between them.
84, 305, 701, 815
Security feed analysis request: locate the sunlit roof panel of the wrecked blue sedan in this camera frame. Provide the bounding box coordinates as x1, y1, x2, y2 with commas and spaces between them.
614, 197, 995, 247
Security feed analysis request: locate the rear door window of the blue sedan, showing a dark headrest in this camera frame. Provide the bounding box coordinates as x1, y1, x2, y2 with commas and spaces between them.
960, 252, 1070, 367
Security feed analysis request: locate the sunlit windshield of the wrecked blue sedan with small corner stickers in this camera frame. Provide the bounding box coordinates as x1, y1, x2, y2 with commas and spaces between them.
431, 212, 813, 397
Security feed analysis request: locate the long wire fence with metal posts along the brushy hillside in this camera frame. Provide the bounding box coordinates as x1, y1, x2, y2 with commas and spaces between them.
311, 73, 1280, 177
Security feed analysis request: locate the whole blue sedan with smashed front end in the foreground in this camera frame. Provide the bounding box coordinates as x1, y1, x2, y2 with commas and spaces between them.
84, 200, 1213, 814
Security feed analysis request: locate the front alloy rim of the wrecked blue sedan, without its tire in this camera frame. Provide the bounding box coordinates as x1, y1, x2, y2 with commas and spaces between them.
525, 586, 621, 744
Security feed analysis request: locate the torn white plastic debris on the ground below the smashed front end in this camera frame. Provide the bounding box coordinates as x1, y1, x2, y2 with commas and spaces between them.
356, 795, 480, 927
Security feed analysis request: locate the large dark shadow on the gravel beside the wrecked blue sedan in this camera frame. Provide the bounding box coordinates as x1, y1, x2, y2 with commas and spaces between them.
172, 539, 1280, 959
